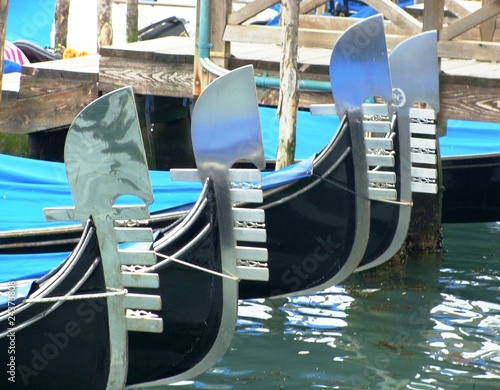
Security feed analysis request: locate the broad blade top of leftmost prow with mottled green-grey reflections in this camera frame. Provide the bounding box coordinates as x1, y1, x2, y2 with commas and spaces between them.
64, 87, 153, 219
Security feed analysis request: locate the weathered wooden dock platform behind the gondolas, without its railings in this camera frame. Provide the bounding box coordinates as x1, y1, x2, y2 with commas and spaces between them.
0, 37, 500, 139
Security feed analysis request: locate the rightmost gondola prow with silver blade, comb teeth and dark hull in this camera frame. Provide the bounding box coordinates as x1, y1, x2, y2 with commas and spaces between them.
350, 31, 439, 271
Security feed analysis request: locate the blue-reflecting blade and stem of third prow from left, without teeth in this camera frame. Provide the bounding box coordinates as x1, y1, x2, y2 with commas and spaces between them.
330, 15, 392, 274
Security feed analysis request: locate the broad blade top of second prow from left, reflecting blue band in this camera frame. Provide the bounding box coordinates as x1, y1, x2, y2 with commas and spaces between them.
191, 65, 265, 180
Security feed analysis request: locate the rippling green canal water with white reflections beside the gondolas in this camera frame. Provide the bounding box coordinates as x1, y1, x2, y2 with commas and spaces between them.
168, 223, 500, 390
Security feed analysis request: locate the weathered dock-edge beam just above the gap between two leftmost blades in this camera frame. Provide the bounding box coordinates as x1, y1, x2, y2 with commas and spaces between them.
99, 57, 194, 97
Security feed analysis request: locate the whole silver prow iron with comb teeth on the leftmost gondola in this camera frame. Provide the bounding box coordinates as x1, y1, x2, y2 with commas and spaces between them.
46, 88, 163, 388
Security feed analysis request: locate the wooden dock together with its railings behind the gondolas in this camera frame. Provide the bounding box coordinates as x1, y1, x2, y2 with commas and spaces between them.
0, 0, 500, 151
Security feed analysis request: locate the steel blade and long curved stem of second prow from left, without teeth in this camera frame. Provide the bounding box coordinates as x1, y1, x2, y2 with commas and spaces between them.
171, 66, 265, 386
